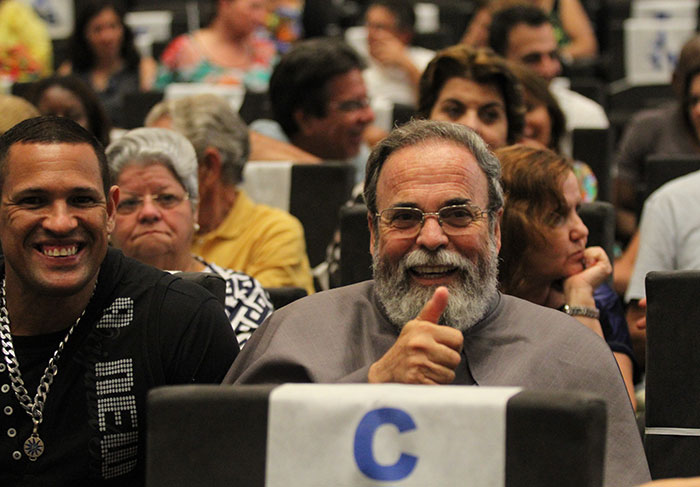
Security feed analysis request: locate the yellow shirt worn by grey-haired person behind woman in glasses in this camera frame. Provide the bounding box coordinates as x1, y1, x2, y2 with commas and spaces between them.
192, 190, 314, 294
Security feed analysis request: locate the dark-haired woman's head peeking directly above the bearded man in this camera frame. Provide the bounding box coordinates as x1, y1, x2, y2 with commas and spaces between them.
418, 45, 525, 149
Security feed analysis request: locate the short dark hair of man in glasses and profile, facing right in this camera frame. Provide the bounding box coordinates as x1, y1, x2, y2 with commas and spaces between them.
269, 38, 365, 137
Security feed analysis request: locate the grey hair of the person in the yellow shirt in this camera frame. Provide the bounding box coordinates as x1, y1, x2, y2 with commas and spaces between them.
145, 94, 250, 185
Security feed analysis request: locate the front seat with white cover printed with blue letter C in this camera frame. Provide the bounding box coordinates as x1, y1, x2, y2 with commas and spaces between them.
146, 384, 606, 487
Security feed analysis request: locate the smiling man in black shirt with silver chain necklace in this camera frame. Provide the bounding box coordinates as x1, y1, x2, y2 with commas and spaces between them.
0, 117, 238, 486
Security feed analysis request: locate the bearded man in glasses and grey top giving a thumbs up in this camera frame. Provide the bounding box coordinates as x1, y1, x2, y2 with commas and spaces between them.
224, 121, 649, 487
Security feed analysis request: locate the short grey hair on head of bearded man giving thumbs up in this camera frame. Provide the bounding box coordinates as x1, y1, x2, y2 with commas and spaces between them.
364, 120, 503, 218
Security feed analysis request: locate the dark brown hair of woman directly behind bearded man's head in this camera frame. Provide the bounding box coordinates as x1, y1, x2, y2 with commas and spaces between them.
417, 44, 525, 144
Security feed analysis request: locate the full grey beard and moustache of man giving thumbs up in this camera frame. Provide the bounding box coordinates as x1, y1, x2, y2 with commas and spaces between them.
373, 239, 498, 332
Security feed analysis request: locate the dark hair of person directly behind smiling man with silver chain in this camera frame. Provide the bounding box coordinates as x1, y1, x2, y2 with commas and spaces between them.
27, 74, 112, 147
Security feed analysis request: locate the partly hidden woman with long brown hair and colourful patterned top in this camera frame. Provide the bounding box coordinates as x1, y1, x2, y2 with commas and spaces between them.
510, 64, 598, 202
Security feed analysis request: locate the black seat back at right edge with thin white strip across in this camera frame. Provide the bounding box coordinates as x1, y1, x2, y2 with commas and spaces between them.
644, 271, 700, 478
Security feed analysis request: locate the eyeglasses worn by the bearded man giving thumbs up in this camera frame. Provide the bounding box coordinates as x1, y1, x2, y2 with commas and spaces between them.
375, 204, 488, 238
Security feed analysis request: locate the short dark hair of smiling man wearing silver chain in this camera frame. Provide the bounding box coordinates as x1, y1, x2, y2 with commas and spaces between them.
0, 115, 111, 197
